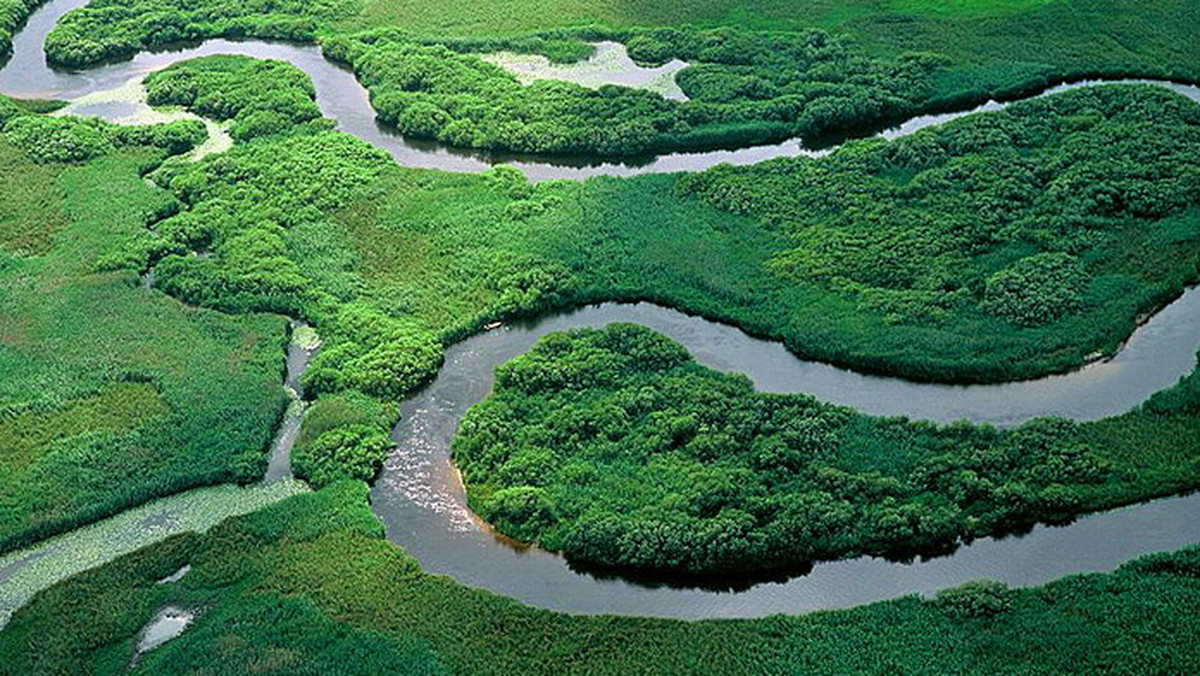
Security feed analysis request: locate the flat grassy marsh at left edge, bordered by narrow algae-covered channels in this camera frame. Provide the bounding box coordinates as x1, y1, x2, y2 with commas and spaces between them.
0, 103, 284, 552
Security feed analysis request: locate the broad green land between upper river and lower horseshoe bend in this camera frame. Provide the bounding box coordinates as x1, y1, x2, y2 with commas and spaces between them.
145, 80, 1200, 397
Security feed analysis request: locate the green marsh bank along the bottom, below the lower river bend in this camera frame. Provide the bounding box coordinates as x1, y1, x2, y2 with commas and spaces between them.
0, 484, 1200, 676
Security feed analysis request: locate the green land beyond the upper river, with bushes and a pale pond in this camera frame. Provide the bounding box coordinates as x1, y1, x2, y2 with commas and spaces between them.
37, 0, 1200, 156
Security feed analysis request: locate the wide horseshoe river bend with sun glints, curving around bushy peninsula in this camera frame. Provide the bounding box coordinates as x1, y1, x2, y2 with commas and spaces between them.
371, 303, 1200, 618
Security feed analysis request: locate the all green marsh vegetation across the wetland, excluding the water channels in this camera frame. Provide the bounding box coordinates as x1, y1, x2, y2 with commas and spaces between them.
0, 0, 1200, 674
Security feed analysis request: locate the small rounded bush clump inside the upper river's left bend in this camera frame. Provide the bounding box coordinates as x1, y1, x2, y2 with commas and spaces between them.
145, 55, 331, 140
